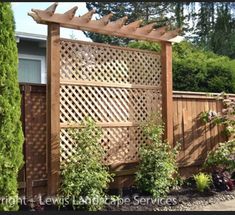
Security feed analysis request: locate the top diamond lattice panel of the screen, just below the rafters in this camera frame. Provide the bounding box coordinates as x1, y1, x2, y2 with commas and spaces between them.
60, 41, 161, 86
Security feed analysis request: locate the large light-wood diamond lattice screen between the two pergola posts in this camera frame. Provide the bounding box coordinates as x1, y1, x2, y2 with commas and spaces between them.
60, 39, 162, 164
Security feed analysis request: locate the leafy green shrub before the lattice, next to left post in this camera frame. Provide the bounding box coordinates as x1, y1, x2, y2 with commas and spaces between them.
60, 118, 112, 211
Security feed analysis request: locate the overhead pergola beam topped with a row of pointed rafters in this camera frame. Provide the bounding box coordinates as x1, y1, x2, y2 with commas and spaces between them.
29, 3, 181, 42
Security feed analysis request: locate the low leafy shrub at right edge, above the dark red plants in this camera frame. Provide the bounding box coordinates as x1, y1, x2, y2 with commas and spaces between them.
204, 140, 235, 171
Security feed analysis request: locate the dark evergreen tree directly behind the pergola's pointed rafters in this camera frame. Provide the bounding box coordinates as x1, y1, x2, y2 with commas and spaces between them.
85, 2, 171, 45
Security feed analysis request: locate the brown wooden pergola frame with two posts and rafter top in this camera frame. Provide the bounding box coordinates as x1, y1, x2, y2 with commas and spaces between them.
29, 3, 180, 194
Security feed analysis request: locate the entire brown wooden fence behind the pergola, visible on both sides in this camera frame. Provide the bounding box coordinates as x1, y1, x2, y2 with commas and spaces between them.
19, 84, 235, 196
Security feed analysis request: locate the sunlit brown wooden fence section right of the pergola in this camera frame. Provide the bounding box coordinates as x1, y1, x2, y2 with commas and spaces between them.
173, 91, 230, 176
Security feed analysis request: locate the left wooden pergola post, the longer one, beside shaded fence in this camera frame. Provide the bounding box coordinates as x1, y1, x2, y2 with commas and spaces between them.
47, 23, 60, 195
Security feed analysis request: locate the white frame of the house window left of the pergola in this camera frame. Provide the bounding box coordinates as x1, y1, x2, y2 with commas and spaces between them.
18, 53, 46, 84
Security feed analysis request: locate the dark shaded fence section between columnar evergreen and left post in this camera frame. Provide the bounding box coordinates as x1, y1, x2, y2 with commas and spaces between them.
19, 84, 48, 197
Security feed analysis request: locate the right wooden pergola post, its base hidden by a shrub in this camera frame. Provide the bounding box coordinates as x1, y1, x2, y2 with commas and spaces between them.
161, 42, 173, 146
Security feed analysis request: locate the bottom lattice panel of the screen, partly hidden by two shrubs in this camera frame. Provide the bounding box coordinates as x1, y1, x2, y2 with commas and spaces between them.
60, 127, 147, 165
